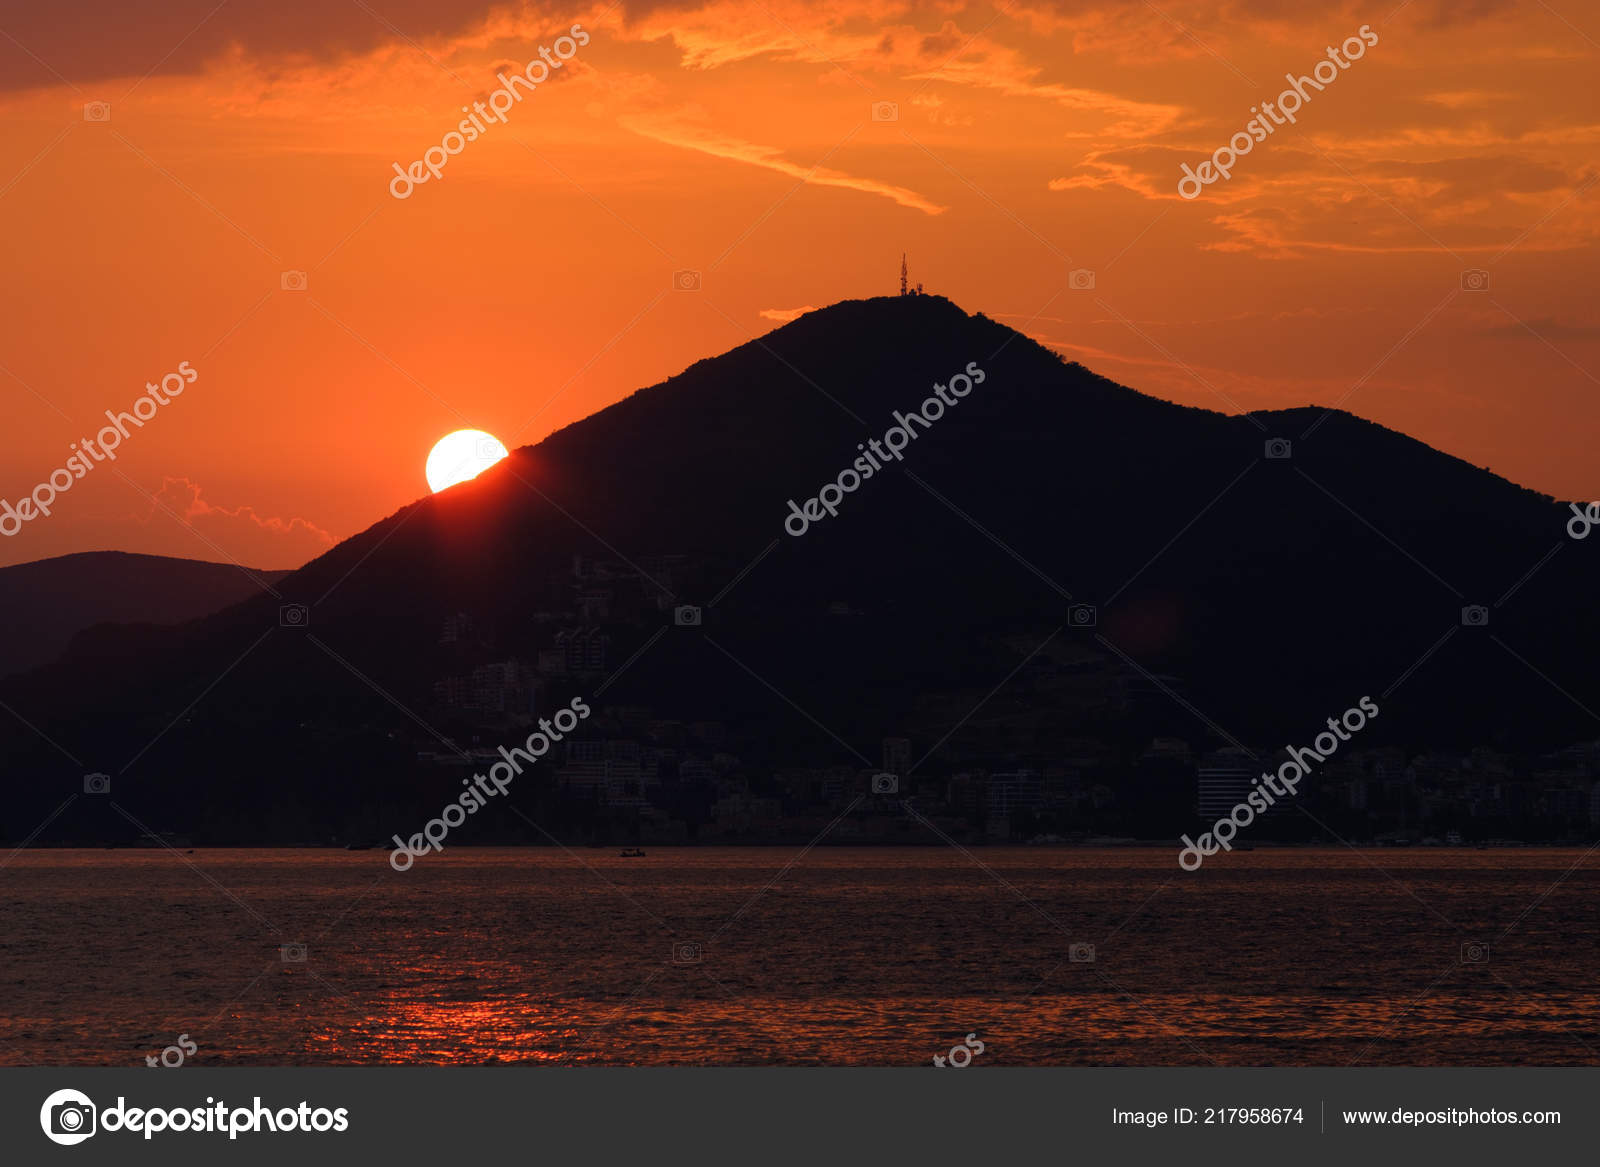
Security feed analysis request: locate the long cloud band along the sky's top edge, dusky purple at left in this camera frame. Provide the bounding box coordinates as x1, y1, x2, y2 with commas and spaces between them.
0, 0, 1536, 98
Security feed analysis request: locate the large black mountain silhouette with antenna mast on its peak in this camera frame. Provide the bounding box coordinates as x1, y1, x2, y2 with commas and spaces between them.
0, 296, 1600, 842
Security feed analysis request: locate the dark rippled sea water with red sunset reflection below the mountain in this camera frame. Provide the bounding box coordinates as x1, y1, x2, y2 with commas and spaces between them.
0, 847, 1600, 1065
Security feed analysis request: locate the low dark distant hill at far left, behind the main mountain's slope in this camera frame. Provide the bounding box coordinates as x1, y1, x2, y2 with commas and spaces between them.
0, 551, 288, 676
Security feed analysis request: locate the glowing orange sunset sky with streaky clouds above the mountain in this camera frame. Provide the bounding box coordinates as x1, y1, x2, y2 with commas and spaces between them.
0, 0, 1600, 568
